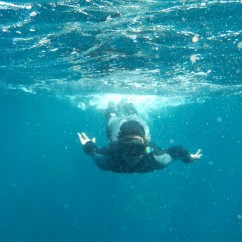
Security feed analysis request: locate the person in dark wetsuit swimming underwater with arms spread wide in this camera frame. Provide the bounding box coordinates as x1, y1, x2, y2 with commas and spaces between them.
78, 100, 202, 173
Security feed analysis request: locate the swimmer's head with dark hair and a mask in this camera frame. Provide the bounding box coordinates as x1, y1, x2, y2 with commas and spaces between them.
118, 120, 146, 164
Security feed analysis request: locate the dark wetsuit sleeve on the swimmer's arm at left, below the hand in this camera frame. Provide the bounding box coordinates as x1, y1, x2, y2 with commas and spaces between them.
83, 141, 110, 170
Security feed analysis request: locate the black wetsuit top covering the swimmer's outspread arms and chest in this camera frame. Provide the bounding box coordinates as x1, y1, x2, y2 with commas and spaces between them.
83, 141, 192, 173
